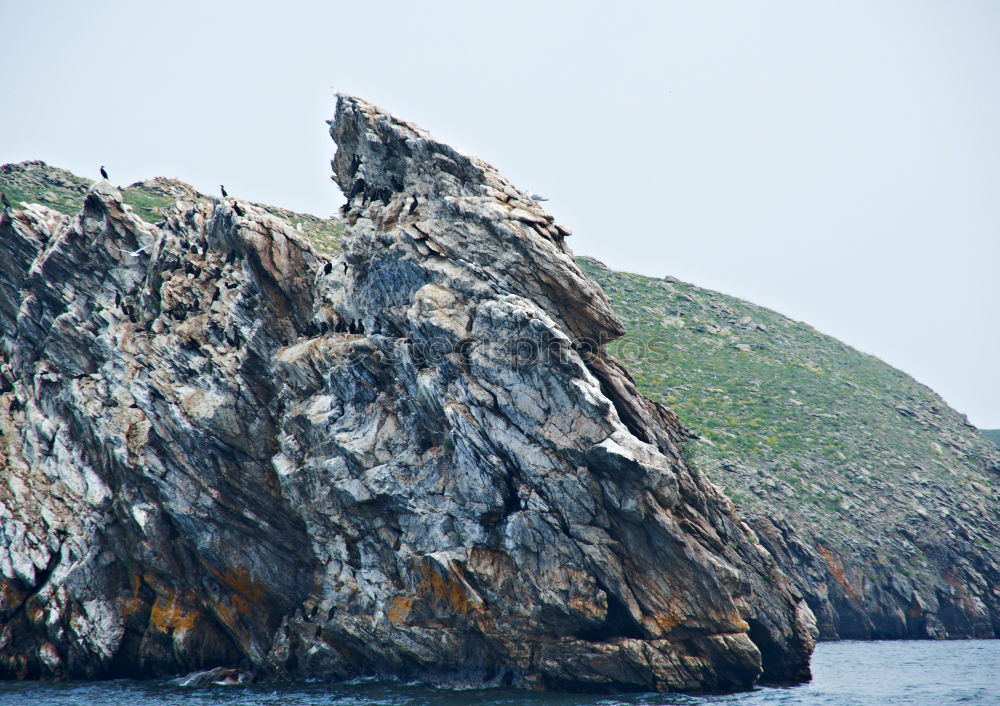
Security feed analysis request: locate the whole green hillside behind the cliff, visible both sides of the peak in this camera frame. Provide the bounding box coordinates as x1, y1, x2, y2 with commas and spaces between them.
0, 161, 1000, 640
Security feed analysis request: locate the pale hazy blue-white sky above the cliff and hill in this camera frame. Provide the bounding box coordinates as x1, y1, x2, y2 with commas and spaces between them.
0, 0, 1000, 428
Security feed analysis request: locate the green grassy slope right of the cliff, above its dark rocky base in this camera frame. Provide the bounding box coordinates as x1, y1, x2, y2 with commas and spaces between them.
578, 252, 1000, 560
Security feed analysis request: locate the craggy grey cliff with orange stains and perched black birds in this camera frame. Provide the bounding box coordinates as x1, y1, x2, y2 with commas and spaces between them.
0, 97, 815, 690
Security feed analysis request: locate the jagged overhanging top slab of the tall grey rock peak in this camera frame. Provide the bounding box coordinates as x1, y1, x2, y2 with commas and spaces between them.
330, 96, 624, 344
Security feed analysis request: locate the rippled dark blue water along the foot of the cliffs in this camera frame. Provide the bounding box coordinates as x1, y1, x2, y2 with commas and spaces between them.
0, 640, 1000, 706
